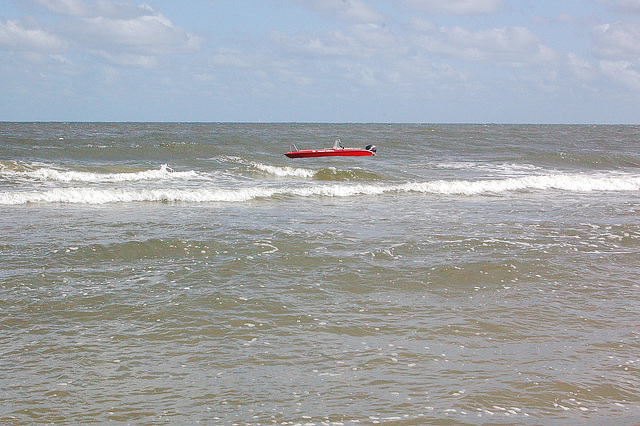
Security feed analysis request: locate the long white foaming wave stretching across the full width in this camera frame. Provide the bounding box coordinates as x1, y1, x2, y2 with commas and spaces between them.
0, 175, 640, 205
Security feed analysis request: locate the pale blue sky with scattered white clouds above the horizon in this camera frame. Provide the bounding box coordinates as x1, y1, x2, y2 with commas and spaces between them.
0, 0, 640, 124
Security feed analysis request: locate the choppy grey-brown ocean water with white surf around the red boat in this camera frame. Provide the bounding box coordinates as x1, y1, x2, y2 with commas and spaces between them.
0, 123, 640, 425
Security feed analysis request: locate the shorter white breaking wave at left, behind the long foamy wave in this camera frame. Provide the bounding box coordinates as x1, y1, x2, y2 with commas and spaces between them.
0, 164, 198, 183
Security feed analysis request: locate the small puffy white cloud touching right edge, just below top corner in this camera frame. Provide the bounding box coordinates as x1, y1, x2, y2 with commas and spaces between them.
592, 22, 640, 59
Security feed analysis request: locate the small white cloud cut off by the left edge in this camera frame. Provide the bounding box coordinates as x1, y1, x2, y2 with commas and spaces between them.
0, 21, 67, 53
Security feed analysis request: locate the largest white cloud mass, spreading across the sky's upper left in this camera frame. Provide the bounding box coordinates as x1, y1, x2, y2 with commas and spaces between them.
0, 0, 204, 68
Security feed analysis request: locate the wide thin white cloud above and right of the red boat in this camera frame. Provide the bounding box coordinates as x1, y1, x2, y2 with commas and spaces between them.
416, 27, 556, 65
